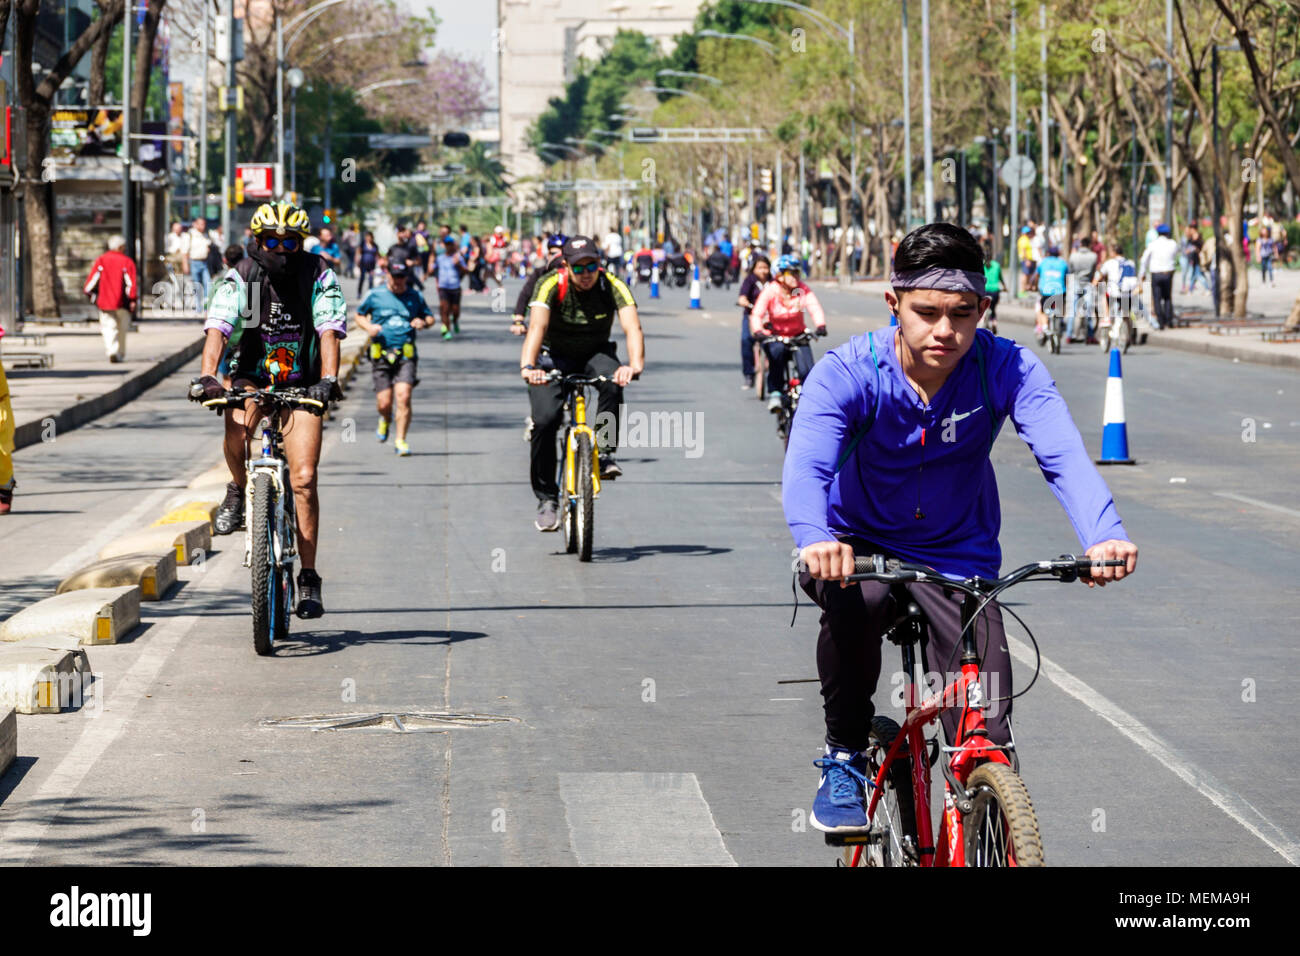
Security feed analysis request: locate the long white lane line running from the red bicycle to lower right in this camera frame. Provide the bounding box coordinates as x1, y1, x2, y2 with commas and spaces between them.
1006, 635, 1300, 866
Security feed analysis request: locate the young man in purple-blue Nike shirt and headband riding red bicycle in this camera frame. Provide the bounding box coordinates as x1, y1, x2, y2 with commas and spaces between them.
784, 222, 1138, 858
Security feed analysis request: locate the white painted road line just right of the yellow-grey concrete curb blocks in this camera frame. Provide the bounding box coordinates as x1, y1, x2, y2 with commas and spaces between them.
0, 551, 243, 866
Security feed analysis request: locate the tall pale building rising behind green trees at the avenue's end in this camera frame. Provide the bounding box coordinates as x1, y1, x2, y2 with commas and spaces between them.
497, 0, 701, 201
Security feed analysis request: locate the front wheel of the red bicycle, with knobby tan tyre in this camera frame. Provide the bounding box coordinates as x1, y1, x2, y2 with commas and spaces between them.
962, 763, 1047, 866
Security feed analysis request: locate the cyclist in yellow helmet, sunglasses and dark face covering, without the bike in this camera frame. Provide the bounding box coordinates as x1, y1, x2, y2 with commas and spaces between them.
191, 202, 347, 618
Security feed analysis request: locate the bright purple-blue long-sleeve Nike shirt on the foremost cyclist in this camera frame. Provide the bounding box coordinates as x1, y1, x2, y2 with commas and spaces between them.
783, 328, 1128, 578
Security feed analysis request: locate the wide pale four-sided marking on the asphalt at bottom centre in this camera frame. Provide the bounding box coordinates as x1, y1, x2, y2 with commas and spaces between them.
559, 773, 736, 866
